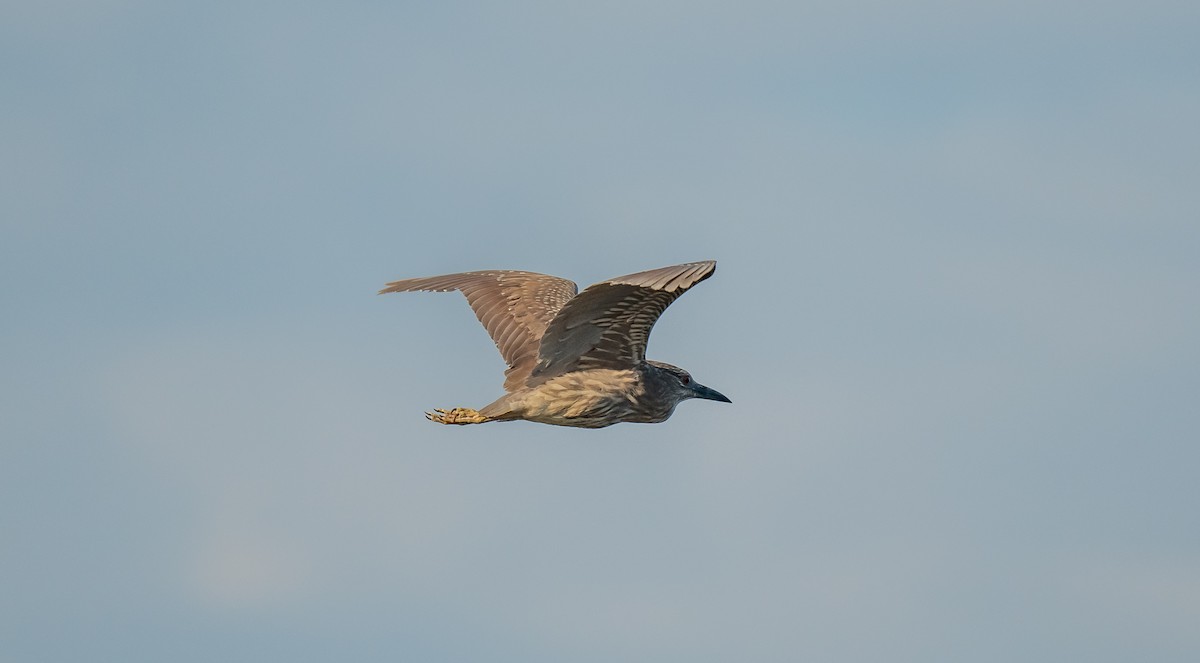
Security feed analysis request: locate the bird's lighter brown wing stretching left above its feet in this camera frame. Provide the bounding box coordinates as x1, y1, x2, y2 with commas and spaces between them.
379, 270, 578, 392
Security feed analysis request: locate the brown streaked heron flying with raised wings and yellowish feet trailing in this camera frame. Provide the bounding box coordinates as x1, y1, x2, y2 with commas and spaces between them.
379, 261, 732, 429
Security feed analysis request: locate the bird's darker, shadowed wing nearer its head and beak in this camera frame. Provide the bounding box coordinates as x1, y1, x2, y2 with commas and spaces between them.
530, 261, 716, 381
